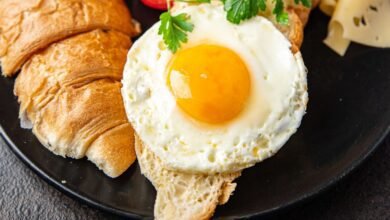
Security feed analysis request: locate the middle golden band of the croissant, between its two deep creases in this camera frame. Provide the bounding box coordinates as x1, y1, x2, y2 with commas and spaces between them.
14, 30, 131, 123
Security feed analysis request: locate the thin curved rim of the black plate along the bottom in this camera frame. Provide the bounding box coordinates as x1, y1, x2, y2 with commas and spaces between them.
0, 124, 390, 219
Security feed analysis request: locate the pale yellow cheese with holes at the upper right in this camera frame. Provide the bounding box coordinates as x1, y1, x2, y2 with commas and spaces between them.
324, 0, 390, 55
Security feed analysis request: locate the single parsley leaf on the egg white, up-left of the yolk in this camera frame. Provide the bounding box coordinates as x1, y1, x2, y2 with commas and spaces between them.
158, 12, 194, 53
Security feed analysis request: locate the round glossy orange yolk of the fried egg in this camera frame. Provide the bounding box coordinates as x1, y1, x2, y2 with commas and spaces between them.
167, 45, 250, 124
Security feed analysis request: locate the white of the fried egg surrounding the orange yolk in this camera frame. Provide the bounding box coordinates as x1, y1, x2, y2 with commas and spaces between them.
122, 4, 308, 174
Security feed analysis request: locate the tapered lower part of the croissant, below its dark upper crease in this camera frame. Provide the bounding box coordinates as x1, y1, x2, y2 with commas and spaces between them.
14, 30, 135, 177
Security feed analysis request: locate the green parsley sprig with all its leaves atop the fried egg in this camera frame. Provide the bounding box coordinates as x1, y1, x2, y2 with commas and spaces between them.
158, 0, 311, 53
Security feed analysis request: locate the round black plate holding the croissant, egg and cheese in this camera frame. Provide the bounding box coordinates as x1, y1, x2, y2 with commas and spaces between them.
0, 0, 390, 217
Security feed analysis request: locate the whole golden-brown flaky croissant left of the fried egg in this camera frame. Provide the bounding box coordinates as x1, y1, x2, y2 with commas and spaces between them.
0, 0, 137, 177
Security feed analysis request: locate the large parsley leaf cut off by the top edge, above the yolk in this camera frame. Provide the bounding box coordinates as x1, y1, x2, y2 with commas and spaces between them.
222, 0, 266, 24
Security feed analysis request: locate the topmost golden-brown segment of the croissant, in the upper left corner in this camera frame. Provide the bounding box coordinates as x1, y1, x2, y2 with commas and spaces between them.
0, 0, 137, 76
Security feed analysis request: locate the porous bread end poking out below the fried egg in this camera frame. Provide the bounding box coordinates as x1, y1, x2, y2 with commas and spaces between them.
135, 136, 241, 220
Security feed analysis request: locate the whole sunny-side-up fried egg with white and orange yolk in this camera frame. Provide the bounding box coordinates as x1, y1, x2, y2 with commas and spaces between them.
122, 1, 308, 174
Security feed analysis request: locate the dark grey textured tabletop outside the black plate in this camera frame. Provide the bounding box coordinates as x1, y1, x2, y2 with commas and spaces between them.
0, 135, 390, 220
